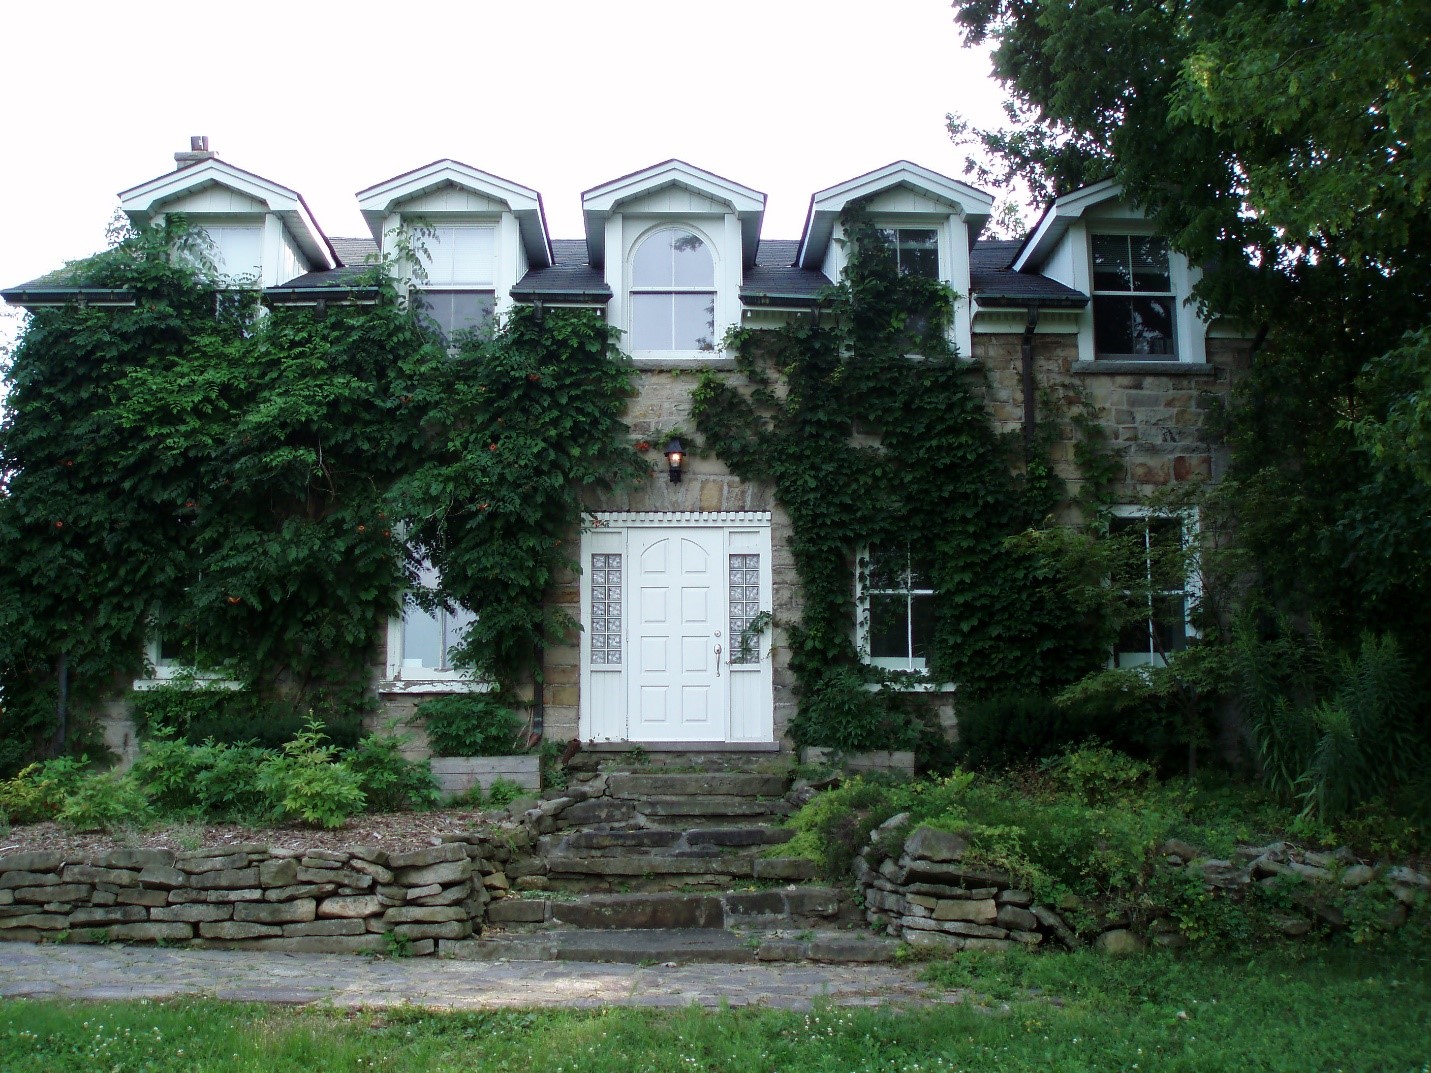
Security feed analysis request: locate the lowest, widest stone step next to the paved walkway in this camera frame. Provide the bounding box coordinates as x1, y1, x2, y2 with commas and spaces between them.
438, 929, 899, 964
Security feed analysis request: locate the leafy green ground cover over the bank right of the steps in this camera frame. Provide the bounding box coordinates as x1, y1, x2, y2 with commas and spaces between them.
780, 745, 1425, 949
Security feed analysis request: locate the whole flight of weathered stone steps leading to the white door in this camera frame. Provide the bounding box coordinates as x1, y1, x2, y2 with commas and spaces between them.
449, 771, 896, 964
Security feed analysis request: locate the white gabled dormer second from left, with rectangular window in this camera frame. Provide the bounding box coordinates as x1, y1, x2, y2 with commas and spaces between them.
358, 160, 551, 332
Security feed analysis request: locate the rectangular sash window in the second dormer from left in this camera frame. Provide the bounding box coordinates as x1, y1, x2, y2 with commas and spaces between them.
411, 225, 497, 340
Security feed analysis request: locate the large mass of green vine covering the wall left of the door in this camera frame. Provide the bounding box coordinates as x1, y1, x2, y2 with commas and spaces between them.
0, 219, 645, 771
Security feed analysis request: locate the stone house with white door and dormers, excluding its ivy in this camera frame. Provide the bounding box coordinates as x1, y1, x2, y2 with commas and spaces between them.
3, 139, 1248, 753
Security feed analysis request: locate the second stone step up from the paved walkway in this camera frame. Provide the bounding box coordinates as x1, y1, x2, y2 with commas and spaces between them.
488, 886, 856, 931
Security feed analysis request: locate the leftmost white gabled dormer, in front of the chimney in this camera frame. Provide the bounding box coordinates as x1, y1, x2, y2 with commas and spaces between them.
119, 152, 338, 288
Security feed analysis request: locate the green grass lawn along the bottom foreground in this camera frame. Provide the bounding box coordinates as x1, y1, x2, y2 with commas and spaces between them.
0, 949, 1431, 1073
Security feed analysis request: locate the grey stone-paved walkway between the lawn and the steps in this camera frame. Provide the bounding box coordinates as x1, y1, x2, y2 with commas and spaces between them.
0, 943, 959, 1010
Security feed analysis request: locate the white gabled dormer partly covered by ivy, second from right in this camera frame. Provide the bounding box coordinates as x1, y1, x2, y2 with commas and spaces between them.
796, 160, 993, 356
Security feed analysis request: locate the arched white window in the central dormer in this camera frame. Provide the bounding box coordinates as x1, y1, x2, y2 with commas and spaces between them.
631, 227, 716, 352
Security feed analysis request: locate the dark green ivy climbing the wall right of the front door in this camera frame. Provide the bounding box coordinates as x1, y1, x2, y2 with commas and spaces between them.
693, 213, 1110, 748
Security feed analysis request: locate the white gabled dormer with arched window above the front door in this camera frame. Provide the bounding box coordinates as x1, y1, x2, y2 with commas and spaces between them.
581, 160, 766, 365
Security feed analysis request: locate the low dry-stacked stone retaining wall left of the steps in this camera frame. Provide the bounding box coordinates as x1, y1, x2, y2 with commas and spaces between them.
0, 834, 509, 956
